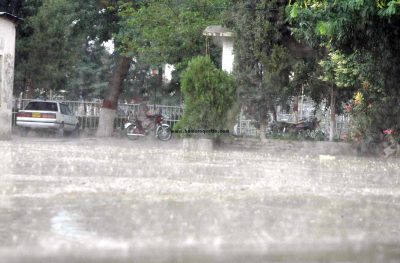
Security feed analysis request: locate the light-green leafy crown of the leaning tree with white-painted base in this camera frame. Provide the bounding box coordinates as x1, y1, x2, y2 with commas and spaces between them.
115, 0, 228, 65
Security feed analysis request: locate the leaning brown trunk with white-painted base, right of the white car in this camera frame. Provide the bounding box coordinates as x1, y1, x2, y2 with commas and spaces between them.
96, 56, 131, 137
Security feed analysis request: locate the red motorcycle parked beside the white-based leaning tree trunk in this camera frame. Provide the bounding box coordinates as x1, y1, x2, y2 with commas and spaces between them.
124, 114, 172, 141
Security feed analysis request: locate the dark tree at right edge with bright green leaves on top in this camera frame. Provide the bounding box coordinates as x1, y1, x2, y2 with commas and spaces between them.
288, 0, 400, 144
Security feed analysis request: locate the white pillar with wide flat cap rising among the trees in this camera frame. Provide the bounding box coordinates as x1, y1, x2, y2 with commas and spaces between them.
203, 26, 235, 73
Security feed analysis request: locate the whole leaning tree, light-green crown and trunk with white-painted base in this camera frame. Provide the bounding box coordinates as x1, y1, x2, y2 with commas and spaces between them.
97, 0, 227, 136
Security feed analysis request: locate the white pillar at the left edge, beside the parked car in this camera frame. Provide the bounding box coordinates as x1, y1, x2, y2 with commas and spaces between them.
0, 12, 18, 140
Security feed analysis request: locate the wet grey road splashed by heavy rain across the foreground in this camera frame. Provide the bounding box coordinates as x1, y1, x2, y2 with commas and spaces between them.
0, 138, 400, 263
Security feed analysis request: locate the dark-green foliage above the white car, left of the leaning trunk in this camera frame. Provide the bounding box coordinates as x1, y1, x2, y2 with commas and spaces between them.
14, 0, 130, 99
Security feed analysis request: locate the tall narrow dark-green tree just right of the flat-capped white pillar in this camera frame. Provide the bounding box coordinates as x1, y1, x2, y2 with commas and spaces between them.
227, 0, 295, 138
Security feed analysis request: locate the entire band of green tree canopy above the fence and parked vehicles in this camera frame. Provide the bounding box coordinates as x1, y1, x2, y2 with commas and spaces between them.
7, 0, 400, 144
